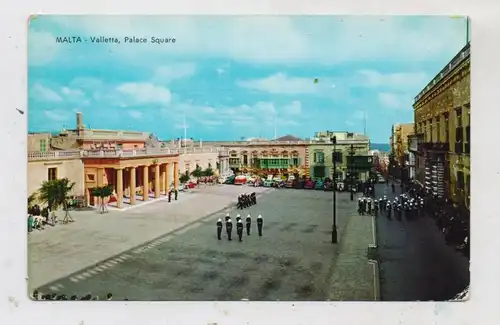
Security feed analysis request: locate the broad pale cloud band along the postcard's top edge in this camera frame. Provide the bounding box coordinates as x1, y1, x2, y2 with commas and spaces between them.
36, 15, 465, 64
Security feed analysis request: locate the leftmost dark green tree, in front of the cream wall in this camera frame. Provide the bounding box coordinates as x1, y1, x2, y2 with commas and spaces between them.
37, 178, 75, 223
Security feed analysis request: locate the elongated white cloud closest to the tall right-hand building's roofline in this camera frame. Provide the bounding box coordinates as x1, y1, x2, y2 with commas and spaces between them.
355, 70, 430, 89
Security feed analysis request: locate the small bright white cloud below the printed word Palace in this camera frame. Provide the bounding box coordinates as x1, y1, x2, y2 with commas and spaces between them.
116, 82, 172, 105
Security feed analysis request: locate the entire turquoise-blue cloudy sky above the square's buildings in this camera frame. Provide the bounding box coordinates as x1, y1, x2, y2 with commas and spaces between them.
28, 15, 466, 143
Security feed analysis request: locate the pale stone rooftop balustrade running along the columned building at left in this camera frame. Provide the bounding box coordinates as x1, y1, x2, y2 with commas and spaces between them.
28, 147, 228, 161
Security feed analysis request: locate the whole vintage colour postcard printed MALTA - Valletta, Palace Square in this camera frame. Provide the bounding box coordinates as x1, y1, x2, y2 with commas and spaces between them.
27, 15, 471, 301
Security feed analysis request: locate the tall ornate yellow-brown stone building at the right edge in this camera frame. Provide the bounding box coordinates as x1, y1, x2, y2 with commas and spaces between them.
413, 43, 470, 209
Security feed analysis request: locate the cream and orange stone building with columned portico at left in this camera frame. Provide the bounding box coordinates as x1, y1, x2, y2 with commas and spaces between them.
28, 113, 229, 208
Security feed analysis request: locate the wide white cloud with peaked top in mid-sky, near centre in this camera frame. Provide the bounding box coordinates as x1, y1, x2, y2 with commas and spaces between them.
236, 73, 323, 95
